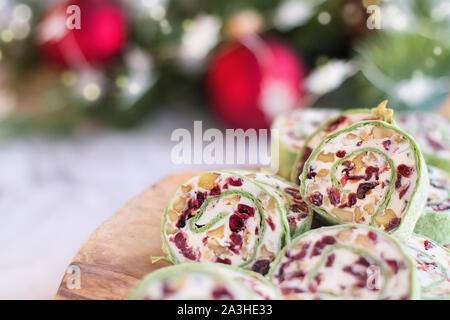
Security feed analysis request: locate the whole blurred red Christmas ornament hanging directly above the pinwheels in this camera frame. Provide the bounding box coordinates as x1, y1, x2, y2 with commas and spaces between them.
206, 36, 305, 129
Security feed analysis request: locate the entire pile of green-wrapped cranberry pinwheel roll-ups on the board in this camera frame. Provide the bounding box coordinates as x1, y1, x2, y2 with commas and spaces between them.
130, 102, 450, 299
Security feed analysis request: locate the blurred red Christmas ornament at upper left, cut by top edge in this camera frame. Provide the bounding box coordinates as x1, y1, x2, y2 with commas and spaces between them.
38, 0, 127, 69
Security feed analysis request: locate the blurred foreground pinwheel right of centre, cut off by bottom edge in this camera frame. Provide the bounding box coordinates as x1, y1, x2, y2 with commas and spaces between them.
269, 224, 420, 300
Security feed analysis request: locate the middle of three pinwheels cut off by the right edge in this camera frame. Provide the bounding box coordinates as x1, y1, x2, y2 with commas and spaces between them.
414, 166, 450, 248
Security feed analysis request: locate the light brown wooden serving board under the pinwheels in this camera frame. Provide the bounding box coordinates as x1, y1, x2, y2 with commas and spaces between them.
55, 171, 199, 300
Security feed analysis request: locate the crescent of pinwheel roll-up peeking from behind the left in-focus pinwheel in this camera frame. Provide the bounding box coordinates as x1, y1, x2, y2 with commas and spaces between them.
227, 170, 313, 238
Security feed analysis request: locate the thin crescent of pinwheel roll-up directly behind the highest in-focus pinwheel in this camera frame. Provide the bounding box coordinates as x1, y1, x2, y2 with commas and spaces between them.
290, 101, 393, 184
